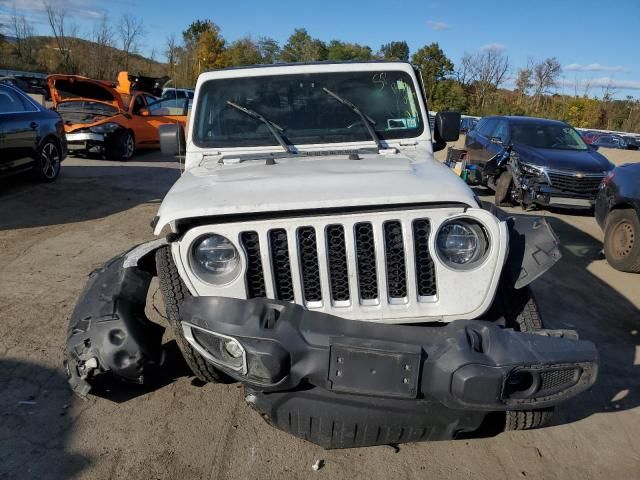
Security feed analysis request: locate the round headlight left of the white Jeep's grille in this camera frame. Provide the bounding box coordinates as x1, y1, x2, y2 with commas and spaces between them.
191, 234, 241, 285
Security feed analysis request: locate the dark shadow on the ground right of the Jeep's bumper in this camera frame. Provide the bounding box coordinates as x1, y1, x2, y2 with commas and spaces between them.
510, 212, 640, 424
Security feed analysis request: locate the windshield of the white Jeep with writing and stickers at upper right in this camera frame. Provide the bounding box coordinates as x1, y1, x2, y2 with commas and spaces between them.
193, 71, 424, 147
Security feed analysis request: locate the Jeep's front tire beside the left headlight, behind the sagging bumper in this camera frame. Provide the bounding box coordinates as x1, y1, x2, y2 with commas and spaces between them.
156, 247, 227, 383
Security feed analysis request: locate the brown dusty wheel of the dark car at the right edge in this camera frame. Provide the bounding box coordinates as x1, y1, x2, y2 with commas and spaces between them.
604, 208, 640, 273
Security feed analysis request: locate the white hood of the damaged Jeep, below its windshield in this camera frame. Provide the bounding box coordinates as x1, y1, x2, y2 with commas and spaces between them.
155, 154, 478, 235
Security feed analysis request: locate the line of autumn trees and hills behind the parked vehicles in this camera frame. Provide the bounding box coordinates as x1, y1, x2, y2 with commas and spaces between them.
0, 13, 640, 132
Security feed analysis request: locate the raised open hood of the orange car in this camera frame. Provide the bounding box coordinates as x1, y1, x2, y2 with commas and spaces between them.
47, 75, 125, 111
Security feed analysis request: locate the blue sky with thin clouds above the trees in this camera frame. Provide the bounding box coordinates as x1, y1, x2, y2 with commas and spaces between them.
0, 0, 640, 98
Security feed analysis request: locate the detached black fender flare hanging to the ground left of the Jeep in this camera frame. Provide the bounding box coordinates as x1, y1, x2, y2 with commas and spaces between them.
64, 239, 167, 396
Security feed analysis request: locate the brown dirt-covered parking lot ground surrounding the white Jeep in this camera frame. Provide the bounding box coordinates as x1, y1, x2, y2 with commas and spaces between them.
0, 152, 640, 480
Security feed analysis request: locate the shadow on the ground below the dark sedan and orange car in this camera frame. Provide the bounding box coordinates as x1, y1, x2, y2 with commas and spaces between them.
0, 155, 180, 231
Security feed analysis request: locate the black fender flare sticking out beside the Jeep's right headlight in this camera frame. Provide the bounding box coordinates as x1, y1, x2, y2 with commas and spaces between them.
505, 215, 562, 288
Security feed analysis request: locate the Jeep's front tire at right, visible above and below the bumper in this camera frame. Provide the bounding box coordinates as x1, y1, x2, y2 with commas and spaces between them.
489, 281, 554, 431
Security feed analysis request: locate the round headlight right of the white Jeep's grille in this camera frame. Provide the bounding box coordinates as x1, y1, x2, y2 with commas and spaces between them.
436, 218, 489, 270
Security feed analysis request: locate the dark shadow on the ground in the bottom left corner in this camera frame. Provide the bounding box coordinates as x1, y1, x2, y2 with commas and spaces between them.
0, 359, 92, 480
